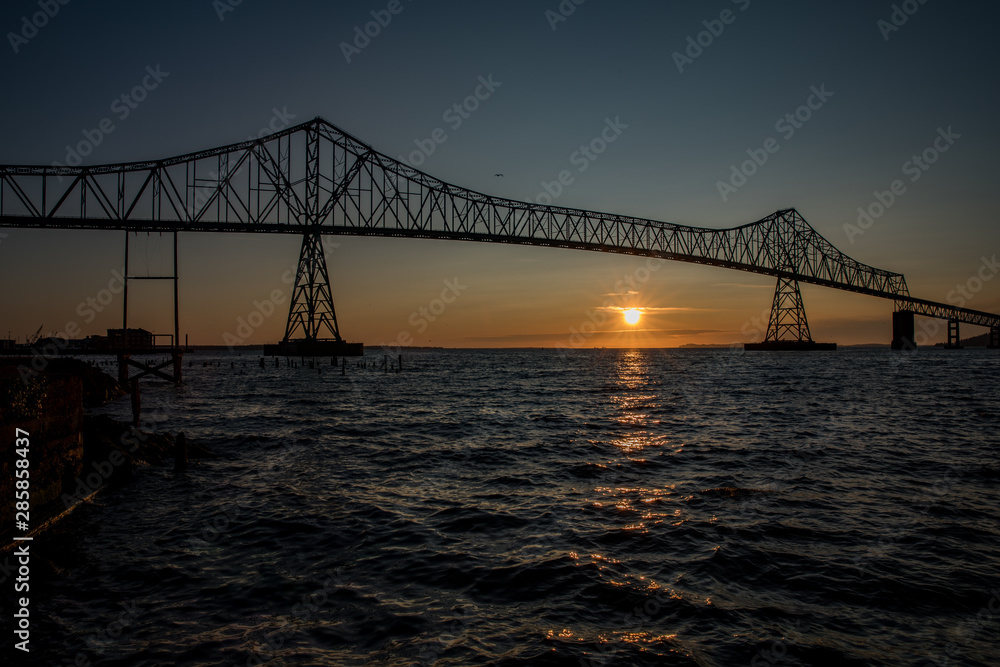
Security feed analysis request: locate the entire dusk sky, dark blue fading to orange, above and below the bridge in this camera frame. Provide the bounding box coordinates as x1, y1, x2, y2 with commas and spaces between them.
0, 0, 1000, 347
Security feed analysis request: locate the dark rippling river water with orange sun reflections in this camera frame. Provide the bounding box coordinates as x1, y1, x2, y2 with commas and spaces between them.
13, 348, 1000, 667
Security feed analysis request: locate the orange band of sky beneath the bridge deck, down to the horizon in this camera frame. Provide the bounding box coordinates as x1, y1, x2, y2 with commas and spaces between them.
0, 235, 984, 349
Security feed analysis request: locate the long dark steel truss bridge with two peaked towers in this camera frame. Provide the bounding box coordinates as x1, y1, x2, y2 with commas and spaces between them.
0, 118, 1000, 354
